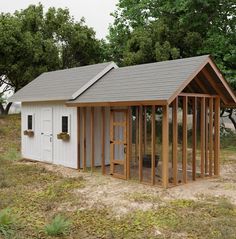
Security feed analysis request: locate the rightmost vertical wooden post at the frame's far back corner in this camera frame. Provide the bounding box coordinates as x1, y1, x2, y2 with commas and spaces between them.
214, 97, 220, 176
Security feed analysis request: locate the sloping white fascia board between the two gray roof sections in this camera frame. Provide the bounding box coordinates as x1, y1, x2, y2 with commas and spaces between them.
72, 62, 118, 100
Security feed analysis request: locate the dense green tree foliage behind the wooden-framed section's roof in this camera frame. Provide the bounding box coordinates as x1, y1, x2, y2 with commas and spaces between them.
108, 0, 236, 84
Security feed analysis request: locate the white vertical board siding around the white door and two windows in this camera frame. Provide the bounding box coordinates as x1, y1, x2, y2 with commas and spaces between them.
21, 102, 77, 168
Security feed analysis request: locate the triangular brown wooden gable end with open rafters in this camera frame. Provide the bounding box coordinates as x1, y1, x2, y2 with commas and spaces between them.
167, 56, 236, 106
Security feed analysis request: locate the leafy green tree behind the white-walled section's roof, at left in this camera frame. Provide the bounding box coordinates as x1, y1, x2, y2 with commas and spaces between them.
0, 4, 103, 114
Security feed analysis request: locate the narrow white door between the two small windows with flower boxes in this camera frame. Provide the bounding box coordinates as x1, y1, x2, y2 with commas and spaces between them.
41, 108, 53, 162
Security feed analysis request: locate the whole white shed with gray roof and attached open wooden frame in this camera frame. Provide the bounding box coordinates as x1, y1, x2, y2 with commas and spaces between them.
10, 55, 236, 188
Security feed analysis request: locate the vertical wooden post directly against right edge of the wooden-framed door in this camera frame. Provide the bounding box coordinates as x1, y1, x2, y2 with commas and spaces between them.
127, 106, 132, 179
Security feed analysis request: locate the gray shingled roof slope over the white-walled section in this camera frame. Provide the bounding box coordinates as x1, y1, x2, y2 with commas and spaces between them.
10, 62, 114, 102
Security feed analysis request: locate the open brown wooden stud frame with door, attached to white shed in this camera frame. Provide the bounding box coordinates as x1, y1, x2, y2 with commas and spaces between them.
74, 61, 234, 188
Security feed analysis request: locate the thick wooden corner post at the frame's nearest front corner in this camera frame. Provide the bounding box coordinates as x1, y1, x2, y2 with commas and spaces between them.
162, 105, 169, 188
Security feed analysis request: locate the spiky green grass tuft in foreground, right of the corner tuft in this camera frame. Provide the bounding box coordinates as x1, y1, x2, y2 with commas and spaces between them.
45, 215, 71, 236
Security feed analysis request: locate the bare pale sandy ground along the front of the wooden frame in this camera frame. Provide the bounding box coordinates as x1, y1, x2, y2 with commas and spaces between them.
30, 160, 236, 217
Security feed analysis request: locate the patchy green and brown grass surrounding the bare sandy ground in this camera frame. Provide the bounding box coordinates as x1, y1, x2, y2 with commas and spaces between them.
0, 115, 236, 239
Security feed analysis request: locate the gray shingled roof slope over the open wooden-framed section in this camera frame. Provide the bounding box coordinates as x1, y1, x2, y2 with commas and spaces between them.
71, 55, 209, 103
